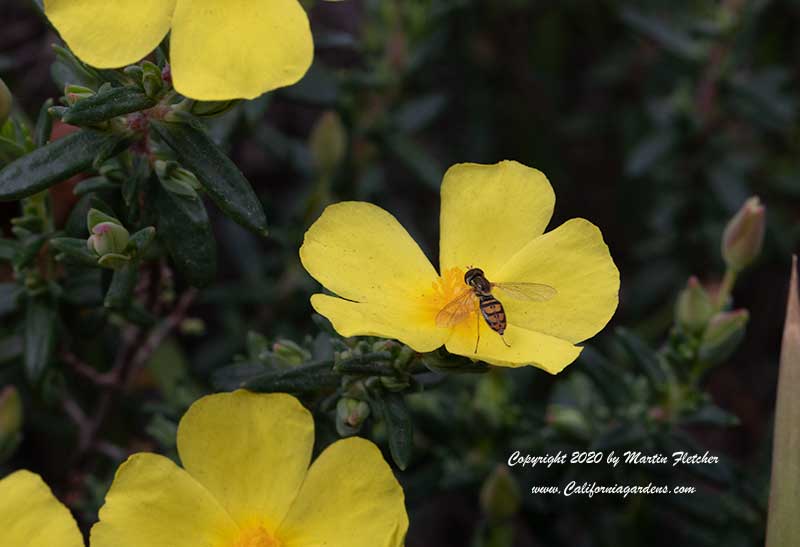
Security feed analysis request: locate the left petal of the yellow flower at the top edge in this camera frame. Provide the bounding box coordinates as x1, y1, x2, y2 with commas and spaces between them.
44, 0, 176, 68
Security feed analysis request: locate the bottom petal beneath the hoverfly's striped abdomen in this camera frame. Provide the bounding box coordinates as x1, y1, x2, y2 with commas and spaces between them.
446, 316, 582, 374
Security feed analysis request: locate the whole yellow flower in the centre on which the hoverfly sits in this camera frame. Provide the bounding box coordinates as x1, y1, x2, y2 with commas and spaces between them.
300, 161, 619, 374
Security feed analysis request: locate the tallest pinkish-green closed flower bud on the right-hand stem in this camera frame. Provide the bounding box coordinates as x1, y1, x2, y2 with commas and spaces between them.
722, 197, 766, 272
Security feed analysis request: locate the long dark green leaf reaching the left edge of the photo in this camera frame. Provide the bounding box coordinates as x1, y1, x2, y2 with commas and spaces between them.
0, 130, 124, 201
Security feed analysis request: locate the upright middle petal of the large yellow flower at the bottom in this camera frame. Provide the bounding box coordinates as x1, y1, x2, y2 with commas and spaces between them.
178, 390, 314, 531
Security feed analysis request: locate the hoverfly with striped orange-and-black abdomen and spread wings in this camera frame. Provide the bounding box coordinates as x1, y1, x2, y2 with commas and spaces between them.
436, 268, 557, 353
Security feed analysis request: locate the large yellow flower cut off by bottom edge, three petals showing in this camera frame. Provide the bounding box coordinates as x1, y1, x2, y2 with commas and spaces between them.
91, 391, 408, 547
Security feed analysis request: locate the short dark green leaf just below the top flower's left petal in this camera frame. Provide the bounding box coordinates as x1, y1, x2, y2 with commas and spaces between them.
61, 87, 156, 125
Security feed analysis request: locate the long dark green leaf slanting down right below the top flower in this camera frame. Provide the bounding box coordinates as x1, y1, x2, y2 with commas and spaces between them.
150, 121, 267, 235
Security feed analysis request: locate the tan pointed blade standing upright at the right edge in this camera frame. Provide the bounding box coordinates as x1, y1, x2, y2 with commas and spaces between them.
767, 256, 800, 547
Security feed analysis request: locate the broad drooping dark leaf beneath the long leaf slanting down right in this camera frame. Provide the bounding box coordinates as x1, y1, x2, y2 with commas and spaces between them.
156, 184, 217, 287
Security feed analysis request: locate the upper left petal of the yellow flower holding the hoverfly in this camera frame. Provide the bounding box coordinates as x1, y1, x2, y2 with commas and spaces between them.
300, 201, 438, 306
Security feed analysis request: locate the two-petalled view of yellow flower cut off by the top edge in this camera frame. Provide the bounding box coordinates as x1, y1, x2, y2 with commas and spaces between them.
44, 0, 314, 100
